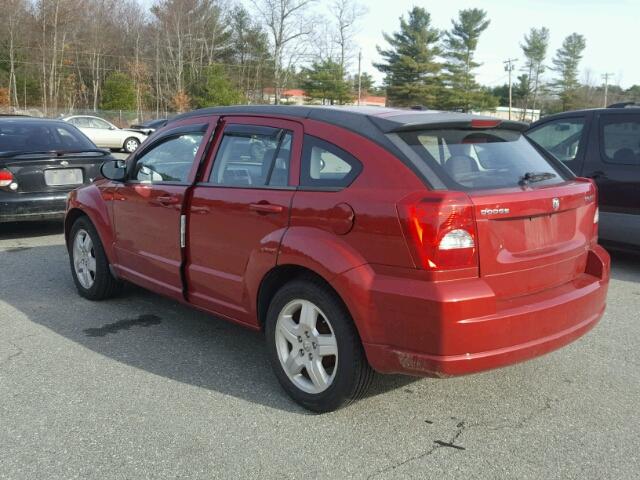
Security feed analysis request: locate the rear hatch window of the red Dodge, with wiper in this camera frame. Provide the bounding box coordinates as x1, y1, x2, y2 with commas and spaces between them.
400, 129, 565, 190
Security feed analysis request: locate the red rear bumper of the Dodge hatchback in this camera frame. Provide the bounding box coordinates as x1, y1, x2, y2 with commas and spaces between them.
342, 246, 610, 377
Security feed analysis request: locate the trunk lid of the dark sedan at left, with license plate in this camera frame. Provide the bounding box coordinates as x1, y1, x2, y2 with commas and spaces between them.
0, 149, 109, 193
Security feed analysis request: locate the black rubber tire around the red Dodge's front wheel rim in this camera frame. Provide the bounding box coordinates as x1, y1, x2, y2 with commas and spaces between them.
68, 217, 122, 300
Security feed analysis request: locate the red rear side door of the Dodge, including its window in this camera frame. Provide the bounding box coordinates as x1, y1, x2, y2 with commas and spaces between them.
186, 117, 302, 323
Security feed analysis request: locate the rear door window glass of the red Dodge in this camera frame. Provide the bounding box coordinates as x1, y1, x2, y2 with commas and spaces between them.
209, 125, 292, 187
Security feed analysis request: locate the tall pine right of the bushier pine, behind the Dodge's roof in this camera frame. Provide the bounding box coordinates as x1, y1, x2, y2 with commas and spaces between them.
444, 8, 496, 112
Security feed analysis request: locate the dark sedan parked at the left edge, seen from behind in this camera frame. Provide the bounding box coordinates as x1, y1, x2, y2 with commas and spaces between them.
0, 117, 112, 223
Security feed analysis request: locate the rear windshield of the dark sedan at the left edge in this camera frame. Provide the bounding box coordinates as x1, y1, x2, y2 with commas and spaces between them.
0, 120, 96, 152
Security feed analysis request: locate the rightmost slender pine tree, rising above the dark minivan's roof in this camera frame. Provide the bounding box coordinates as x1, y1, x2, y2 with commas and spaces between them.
552, 33, 586, 110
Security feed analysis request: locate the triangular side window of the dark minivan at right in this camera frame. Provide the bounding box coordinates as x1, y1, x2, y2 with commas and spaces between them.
527, 118, 584, 167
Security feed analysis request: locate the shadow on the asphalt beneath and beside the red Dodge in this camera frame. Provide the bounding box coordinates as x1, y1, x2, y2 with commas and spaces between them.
0, 244, 417, 414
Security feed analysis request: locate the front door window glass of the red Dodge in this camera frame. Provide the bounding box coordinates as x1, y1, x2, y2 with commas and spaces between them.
133, 133, 204, 183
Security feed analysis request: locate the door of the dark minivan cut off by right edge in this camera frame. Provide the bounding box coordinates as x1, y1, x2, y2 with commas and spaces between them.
583, 109, 640, 246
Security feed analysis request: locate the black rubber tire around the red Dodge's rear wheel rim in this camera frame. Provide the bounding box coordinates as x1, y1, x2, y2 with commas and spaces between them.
265, 277, 374, 413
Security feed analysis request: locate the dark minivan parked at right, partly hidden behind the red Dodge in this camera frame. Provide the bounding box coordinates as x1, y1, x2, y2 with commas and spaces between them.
526, 104, 640, 249
